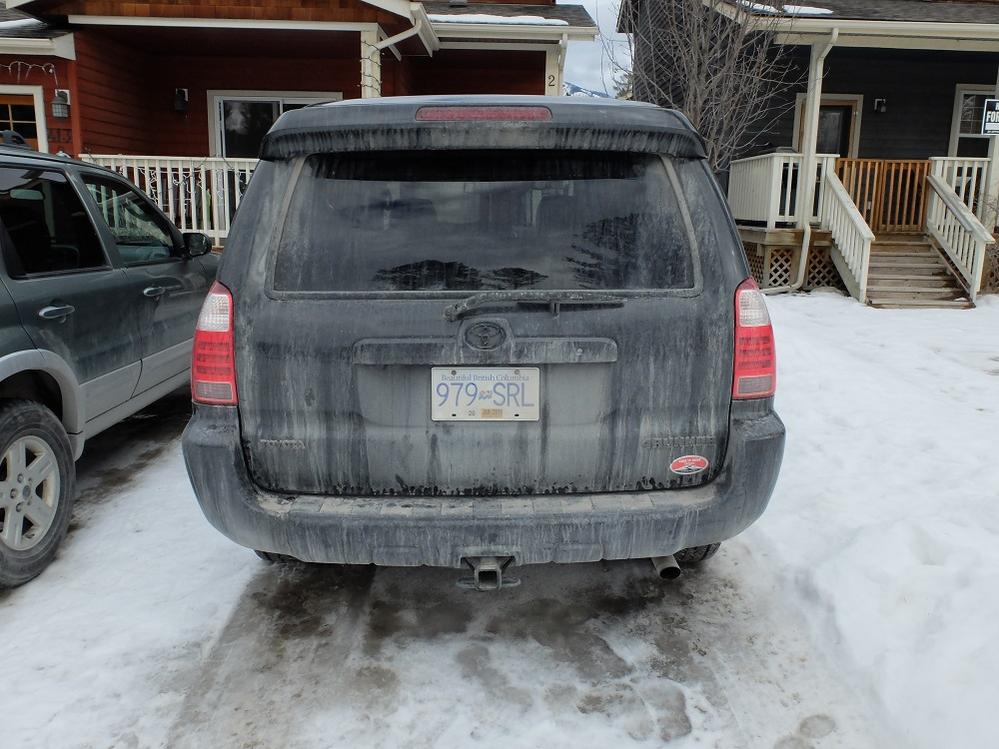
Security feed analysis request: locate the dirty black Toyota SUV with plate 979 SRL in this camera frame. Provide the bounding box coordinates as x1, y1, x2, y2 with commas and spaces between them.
184, 97, 784, 588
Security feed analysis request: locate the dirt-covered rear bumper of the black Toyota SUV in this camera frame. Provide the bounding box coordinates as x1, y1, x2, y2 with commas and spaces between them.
183, 402, 784, 567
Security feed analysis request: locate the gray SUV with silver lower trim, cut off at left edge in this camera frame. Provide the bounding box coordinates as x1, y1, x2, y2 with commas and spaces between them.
0, 146, 217, 588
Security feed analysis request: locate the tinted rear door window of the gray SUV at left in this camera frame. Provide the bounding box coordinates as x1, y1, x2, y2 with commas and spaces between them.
0, 167, 107, 278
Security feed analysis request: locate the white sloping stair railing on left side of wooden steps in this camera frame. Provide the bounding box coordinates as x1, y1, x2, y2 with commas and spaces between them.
819, 169, 874, 304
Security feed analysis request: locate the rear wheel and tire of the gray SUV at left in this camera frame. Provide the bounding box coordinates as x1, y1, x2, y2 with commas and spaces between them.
0, 400, 76, 588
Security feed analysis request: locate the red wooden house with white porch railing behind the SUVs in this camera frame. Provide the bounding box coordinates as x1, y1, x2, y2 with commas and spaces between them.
0, 0, 597, 239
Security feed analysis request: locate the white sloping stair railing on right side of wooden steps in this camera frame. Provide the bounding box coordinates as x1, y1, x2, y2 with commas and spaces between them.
926, 174, 995, 303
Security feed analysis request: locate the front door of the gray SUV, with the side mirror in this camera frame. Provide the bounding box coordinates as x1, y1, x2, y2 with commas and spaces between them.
81, 172, 208, 393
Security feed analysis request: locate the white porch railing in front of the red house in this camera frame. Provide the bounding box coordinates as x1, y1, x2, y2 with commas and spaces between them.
83, 154, 257, 244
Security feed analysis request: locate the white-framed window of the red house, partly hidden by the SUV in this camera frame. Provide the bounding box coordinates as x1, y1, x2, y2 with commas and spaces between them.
208, 91, 343, 158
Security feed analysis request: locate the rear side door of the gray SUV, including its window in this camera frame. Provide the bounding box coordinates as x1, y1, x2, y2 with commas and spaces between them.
0, 165, 141, 421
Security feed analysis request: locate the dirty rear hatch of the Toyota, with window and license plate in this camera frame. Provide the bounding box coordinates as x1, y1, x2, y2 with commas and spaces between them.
237, 151, 732, 495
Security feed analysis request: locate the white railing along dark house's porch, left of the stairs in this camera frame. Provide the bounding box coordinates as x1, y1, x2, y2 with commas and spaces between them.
728, 153, 837, 229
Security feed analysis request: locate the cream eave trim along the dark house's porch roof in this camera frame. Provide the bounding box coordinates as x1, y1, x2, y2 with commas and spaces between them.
720, 0, 999, 52
